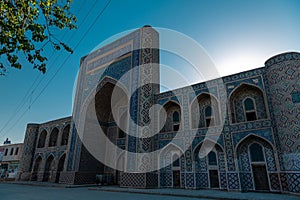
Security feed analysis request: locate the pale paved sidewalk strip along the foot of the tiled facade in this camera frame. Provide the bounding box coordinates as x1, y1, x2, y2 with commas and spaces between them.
89, 186, 300, 200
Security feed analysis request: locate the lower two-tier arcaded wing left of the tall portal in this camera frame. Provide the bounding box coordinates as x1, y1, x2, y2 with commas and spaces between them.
18, 117, 71, 182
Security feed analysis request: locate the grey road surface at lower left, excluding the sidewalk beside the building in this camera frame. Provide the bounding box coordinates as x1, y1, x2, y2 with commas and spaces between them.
0, 183, 206, 200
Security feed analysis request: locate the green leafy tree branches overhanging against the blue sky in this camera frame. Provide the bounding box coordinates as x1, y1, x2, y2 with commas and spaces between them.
0, 0, 77, 75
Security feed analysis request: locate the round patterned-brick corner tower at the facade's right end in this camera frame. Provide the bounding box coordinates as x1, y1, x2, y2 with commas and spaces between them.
265, 52, 300, 192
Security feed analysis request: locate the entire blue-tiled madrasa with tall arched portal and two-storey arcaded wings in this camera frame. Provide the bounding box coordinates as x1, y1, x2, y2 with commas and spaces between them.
17, 26, 300, 193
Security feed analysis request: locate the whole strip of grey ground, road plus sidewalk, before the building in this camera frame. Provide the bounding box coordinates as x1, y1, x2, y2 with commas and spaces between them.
0, 182, 300, 200
